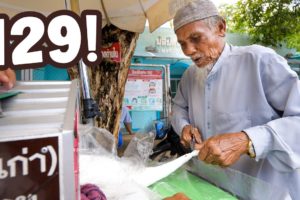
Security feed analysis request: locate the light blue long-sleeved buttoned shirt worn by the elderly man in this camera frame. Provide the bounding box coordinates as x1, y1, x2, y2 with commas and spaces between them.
172, 44, 300, 199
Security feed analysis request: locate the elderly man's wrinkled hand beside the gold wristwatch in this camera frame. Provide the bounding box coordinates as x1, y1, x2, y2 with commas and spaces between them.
198, 132, 249, 167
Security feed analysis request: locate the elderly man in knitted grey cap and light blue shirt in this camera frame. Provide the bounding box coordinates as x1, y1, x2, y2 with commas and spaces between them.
172, 0, 300, 199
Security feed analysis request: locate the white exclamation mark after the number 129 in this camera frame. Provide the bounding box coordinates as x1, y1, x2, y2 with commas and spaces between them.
86, 15, 99, 62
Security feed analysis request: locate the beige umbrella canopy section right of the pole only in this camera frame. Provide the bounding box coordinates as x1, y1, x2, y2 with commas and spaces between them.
79, 0, 174, 33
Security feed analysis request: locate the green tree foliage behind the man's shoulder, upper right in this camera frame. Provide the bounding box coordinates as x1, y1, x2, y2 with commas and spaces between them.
220, 0, 300, 51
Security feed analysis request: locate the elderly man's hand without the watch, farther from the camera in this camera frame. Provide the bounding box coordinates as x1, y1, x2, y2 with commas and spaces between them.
180, 125, 202, 148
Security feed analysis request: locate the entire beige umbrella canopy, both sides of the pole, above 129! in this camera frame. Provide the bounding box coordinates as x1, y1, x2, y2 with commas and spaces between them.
0, 0, 183, 33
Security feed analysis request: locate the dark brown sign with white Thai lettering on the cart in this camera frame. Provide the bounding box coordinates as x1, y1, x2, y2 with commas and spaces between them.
0, 137, 60, 200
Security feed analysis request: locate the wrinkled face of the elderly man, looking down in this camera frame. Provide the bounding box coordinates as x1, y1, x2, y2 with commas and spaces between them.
175, 20, 226, 67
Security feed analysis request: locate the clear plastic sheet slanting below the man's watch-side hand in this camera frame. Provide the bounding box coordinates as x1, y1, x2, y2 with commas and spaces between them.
188, 159, 291, 200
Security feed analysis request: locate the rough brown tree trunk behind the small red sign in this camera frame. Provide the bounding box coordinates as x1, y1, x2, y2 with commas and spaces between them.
68, 25, 139, 138
